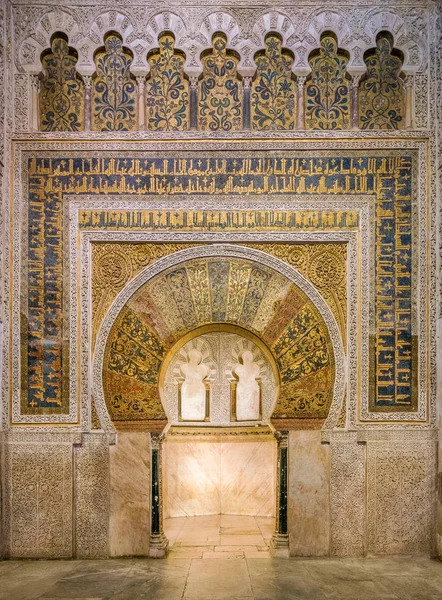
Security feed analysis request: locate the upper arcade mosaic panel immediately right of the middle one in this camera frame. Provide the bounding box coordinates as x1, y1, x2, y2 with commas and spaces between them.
251, 33, 296, 129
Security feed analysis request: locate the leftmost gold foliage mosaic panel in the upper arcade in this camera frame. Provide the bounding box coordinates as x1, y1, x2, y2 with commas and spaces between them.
40, 36, 84, 131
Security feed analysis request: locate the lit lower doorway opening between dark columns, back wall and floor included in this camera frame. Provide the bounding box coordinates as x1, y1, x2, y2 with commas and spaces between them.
163, 432, 277, 558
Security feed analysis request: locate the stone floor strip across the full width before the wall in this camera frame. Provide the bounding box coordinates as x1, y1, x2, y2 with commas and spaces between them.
0, 557, 442, 600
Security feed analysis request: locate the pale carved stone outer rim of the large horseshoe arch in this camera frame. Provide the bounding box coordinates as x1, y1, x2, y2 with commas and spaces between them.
91, 244, 346, 432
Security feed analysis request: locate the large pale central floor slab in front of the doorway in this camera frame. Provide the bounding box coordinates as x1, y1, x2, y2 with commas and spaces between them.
184, 559, 253, 600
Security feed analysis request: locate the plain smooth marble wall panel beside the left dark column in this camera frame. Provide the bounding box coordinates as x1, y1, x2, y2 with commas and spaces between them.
109, 432, 151, 556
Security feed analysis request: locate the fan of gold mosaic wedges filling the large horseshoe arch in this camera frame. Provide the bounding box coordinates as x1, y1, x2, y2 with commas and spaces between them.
103, 256, 335, 427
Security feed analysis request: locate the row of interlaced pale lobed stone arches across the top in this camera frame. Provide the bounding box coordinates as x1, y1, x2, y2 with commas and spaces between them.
15, 8, 426, 76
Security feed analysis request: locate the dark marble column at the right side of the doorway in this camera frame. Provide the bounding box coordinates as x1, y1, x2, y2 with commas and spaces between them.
271, 431, 289, 556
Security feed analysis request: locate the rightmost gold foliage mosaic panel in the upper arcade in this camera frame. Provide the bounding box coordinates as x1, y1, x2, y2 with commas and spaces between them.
359, 35, 404, 129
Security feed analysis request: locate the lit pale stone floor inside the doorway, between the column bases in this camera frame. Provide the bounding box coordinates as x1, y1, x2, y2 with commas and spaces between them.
164, 515, 275, 559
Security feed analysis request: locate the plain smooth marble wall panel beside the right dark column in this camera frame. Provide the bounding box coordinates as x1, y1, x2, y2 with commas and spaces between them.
288, 431, 330, 556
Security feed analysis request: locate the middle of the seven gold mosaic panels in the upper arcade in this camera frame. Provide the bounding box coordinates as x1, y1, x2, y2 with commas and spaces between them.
198, 33, 243, 131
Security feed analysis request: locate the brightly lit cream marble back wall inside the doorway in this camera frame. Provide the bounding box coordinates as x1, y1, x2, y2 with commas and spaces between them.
163, 437, 276, 517
